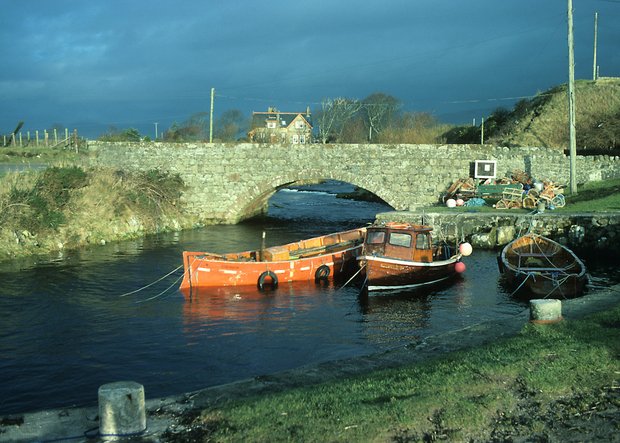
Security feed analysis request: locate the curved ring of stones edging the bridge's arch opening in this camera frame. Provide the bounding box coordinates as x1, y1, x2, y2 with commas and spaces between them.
230, 171, 391, 220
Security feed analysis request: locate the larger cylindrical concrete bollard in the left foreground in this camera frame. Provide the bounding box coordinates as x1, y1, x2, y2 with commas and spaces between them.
99, 381, 146, 437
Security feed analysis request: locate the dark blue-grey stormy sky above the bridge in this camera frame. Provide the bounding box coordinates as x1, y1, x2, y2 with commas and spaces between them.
0, 0, 620, 138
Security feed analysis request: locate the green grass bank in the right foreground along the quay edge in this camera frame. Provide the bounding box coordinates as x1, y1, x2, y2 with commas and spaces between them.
164, 306, 620, 442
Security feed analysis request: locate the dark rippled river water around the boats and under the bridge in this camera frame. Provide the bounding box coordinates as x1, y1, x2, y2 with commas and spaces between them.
0, 183, 612, 415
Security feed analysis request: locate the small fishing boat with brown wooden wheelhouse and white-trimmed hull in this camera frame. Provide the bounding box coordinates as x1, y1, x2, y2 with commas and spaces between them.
357, 223, 471, 291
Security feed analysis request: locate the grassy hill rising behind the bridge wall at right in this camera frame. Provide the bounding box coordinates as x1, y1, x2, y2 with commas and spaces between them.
445, 77, 620, 153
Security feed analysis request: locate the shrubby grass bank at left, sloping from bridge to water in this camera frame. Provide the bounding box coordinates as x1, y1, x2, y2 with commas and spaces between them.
0, 166, 197, 260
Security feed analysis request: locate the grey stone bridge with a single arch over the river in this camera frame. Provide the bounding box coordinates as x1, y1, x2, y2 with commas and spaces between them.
89, 142, 620, 223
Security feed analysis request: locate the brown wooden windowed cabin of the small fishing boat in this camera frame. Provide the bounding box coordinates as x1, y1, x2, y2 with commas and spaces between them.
364, 223, 433, 263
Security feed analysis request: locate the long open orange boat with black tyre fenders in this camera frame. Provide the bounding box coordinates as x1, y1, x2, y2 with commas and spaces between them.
180, 228, 366, 291
